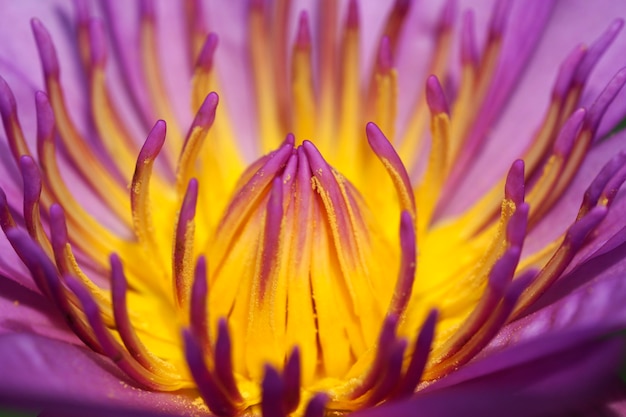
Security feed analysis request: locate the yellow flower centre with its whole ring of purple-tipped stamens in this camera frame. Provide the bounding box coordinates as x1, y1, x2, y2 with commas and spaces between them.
0, 0, 626, 417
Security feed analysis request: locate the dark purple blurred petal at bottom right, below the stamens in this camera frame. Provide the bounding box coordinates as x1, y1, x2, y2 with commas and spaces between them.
353, 339, 624, 417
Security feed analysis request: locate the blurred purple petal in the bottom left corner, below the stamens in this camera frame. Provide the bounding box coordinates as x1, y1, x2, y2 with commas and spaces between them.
0, 334, 208, 416
